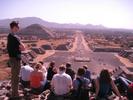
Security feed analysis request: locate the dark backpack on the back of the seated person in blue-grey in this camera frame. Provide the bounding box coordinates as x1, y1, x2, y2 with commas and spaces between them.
76, 78, 89, 100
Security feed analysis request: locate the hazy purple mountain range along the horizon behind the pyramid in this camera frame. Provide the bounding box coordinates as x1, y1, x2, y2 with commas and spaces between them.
0, 17, 105, 29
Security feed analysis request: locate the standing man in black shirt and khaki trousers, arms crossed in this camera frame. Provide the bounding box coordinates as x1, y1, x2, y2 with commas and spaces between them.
7, 21, 25, 98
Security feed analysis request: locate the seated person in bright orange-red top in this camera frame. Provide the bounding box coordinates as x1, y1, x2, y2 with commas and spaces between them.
30, 63, 44, 94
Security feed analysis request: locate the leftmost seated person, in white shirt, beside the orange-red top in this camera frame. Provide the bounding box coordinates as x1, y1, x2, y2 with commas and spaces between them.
20, 63, 34, 88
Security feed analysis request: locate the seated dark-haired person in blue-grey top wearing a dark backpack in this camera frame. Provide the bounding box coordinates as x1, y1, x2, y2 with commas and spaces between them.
73, 68, 90, 100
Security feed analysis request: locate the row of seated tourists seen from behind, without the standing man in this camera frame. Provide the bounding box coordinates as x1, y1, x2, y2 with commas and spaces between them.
20, 62, 133, 100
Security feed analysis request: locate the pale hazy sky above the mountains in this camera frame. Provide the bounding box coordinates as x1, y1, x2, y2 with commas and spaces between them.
0, 0, 133, 29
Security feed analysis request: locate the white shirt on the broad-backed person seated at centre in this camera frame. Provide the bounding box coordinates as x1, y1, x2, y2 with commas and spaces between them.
51, 72, 72, 95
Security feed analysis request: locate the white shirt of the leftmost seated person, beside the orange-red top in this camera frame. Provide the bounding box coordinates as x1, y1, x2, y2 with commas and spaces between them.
20, 65, 34, 81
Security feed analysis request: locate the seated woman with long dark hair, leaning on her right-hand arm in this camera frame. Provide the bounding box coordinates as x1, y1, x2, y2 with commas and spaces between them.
95, 69, 121, 100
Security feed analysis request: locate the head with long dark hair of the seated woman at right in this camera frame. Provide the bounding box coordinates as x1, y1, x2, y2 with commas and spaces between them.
100, 69, 111, 83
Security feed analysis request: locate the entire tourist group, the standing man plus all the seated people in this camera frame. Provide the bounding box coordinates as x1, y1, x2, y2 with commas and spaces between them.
7, 21, 133, 100
